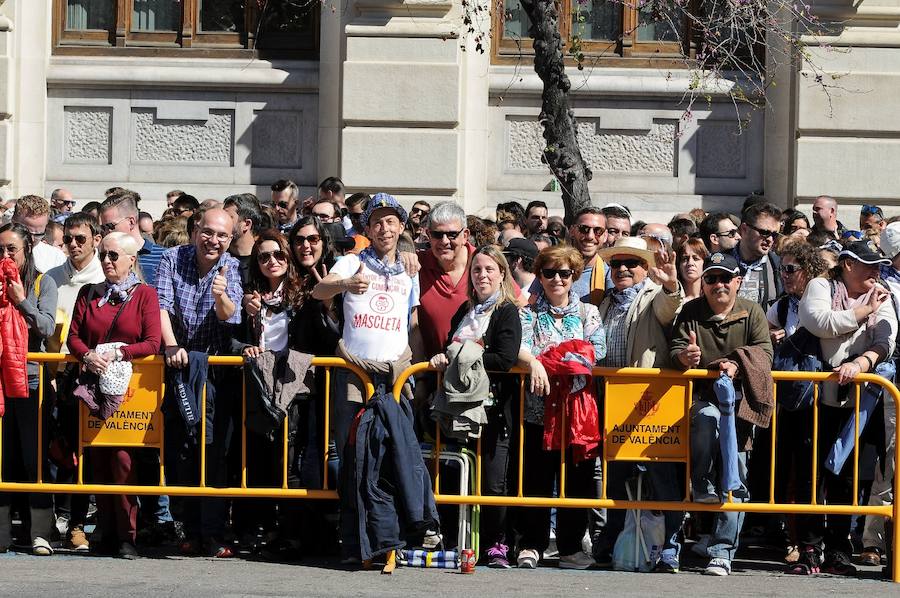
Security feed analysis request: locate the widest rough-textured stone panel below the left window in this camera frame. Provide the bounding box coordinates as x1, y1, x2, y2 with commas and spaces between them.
131, 108, 234, 166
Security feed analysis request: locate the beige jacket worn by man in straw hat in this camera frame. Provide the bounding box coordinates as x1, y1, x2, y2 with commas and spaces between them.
600, 278, 684, 368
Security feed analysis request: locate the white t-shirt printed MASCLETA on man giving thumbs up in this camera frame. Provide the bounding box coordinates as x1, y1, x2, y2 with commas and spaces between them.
331, 254, 419, 361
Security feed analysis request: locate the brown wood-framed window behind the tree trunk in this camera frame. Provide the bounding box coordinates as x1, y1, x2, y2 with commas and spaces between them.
492, 0, 693, 65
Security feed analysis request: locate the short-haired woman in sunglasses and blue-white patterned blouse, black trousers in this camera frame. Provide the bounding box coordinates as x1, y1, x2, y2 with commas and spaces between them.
518, 245, 606, 569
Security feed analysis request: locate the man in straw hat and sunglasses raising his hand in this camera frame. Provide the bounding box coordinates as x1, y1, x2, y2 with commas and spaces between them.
594, 237, 684, 573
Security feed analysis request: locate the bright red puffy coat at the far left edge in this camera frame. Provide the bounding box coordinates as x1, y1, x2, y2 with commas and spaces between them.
0, 257, 28, 416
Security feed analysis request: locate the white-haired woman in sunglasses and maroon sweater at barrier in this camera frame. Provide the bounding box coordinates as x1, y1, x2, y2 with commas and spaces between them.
67, 232, 162, 559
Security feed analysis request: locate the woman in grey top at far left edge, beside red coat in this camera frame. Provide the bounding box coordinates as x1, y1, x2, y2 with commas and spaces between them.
0, 223, 57, 556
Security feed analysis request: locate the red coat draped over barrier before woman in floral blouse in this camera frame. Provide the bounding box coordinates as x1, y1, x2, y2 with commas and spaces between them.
537, 340, 601, 462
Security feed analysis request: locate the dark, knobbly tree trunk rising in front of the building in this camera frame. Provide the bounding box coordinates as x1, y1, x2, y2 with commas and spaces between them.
520, 0, 591, 225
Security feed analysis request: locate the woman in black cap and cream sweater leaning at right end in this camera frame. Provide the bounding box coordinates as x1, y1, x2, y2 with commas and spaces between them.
791, 241, 897, 575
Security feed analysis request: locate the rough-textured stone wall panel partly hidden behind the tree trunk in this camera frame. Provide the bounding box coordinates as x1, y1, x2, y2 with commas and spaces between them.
506, 117, 678, 176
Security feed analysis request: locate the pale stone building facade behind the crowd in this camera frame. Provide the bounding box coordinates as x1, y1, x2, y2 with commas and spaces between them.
0, 0, 900, 222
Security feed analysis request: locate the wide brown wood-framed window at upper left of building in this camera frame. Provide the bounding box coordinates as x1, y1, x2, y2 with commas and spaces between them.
53, 0, 319, 58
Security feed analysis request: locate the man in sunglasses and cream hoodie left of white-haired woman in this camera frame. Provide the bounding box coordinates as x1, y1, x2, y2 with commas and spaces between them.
47, 212, 106, 552
